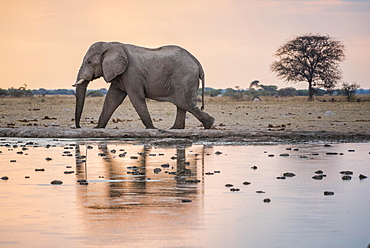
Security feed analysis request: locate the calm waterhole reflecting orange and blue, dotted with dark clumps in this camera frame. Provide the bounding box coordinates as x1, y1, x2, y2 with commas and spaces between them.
0, 139, 370, 247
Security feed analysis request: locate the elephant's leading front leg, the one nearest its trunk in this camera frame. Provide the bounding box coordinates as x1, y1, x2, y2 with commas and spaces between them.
96, 84, 127, 128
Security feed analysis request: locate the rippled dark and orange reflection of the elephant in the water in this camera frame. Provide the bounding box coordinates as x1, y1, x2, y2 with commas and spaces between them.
76, 143, 204, 208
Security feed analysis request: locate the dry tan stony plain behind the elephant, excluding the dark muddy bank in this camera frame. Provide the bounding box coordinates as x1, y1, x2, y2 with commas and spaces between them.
0, 96, 370, 136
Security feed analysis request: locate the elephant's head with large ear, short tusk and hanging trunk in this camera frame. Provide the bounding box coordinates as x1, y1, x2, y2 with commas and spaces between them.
73, 42, 128, 128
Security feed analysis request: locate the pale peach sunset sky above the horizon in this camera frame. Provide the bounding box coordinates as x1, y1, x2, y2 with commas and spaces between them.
0, 0, 370, 89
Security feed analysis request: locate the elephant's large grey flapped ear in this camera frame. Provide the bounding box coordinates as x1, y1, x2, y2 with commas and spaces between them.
102, 45, 128, 83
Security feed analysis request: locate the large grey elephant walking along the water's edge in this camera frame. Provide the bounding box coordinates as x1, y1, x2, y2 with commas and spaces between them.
74, 42, 214, 129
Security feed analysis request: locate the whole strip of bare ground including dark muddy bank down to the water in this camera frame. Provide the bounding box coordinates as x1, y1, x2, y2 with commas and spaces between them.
0, 96, 370, 142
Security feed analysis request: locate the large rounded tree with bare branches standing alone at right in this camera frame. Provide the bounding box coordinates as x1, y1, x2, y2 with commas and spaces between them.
271, 34, 345, 101
